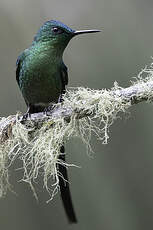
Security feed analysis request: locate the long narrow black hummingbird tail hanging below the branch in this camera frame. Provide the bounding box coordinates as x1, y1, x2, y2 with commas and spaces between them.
58, 146, 77, 223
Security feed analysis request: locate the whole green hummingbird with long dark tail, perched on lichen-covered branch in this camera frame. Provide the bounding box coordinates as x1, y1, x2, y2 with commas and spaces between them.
16, 20, 100, 223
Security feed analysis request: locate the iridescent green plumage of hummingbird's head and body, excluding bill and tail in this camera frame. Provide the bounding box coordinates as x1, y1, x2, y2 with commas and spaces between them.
16, 21, 74, 113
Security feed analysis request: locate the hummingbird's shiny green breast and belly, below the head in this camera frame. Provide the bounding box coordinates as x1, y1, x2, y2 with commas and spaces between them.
19, 45, 62, 107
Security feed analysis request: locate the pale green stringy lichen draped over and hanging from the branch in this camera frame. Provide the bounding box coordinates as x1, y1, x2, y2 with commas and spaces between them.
0, 67, 153, 199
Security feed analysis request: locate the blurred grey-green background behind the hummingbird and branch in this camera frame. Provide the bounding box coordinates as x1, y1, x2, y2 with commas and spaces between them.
0, 0, 153, 230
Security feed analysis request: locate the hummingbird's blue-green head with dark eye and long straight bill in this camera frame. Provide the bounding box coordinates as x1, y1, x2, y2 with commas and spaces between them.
34, 20, 100, 50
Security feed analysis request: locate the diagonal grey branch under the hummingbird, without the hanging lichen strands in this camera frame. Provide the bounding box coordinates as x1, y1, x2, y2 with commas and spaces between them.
0, 69, 153, 131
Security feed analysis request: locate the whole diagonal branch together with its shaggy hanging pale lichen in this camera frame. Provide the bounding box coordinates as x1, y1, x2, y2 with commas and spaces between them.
0, 66, 153, 199
